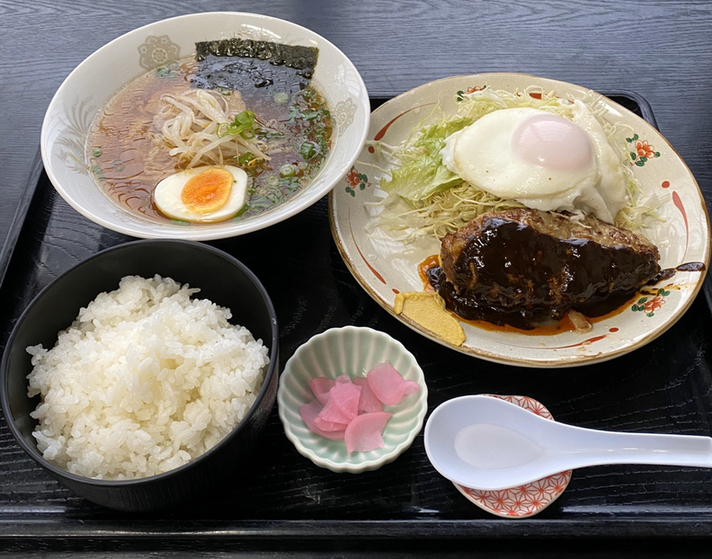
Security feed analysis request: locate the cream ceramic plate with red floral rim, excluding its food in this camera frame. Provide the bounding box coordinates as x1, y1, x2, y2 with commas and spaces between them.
330, 73, 710, 367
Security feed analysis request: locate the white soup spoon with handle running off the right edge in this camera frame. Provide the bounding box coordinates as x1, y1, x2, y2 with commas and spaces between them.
425, 396, 712, 490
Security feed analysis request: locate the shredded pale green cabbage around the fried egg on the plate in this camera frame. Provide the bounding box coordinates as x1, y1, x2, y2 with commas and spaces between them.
376, 87, 659, 242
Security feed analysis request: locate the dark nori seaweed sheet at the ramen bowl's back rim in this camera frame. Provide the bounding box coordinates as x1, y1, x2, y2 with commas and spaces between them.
191, 38, 319, 94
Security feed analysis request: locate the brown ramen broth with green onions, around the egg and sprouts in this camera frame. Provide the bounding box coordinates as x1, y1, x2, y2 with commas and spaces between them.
87, 59, 332, 222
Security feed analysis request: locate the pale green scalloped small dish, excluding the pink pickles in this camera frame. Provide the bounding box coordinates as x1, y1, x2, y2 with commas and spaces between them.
277, 326, 428, 473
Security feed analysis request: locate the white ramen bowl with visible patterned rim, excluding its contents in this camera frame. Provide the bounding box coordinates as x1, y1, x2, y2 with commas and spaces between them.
40, 12, 371, 240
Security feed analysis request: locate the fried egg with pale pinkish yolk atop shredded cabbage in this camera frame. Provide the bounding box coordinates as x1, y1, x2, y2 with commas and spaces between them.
441, 100, 628, 223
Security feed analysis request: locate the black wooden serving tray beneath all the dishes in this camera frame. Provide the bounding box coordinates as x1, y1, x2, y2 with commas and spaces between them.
0, 92, 712, 557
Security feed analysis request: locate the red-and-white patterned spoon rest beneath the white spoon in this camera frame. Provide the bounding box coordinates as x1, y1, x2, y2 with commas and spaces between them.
454, 394, 572, 518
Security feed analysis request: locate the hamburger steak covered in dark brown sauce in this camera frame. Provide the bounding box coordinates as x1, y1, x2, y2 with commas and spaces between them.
428, 208, 660, 329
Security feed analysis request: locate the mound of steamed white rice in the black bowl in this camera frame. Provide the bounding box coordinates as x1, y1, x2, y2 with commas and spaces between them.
27, 275, 269, 479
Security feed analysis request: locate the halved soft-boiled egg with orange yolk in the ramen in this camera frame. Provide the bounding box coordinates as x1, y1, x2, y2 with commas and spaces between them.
153, 165, 247, 223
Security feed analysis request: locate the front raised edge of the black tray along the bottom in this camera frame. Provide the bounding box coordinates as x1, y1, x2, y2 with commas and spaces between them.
0, 514, 712, 542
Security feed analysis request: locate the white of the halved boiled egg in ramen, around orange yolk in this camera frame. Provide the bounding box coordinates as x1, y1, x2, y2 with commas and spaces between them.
153, 165, 247, 223
